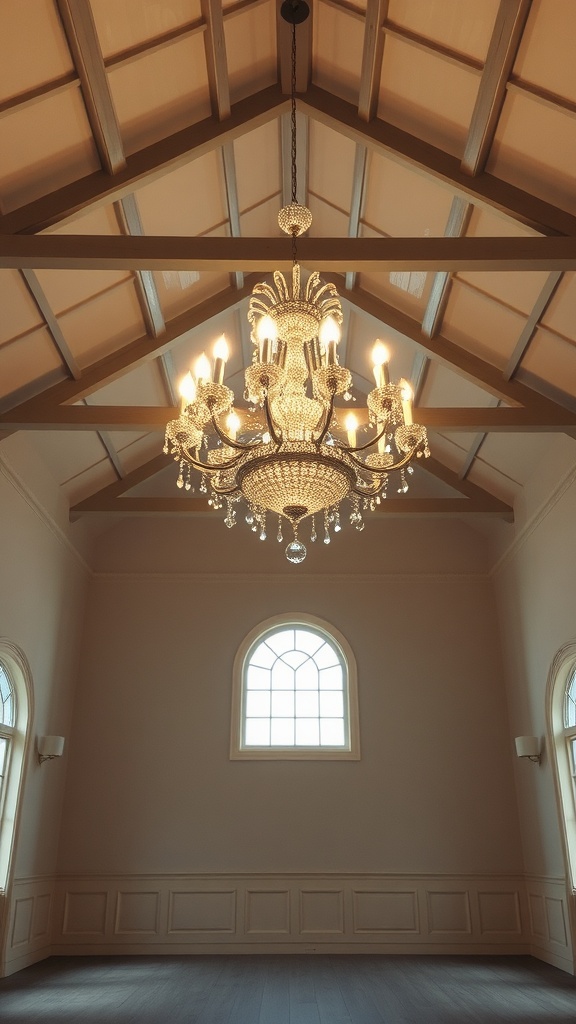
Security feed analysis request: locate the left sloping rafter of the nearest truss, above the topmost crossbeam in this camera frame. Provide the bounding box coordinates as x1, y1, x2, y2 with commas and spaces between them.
0, 85, 289, 233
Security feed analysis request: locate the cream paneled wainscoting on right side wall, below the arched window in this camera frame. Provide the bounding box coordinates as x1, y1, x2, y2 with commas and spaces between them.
526, 876, 574, 974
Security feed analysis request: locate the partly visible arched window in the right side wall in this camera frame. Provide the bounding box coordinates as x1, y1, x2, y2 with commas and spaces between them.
548, 643, 576, 890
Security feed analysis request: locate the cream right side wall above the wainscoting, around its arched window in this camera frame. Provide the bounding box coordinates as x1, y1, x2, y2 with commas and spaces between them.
494, 437, 576, 877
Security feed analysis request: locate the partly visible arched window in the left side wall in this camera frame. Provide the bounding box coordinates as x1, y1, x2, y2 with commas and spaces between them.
0, 639, 32, 890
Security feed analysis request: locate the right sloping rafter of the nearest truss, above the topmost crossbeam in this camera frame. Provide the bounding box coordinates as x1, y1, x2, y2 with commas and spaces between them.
299, 85, 576, 234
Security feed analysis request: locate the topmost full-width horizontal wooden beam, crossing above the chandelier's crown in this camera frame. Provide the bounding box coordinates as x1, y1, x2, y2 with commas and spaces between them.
0, 234, 576, 273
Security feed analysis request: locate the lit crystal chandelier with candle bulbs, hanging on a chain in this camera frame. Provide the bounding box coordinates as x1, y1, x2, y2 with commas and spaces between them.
164, 0, 429, 563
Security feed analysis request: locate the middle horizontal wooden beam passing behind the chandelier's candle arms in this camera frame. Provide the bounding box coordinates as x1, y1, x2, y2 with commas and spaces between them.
0, 403, 576, 433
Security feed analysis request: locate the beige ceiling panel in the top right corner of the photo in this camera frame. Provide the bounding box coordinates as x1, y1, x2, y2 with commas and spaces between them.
515, 0, 576, 102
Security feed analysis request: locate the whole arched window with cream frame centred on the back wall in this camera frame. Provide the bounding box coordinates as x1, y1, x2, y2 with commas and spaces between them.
231, 614, 360, 760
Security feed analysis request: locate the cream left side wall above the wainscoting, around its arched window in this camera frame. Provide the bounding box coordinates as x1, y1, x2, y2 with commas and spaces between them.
0, 435, 88, 877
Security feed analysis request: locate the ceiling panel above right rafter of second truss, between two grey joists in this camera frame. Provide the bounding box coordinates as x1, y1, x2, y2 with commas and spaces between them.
442, 274, 526, 369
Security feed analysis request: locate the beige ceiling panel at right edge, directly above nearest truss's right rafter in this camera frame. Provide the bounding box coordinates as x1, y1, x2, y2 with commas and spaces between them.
487, 92, 576, 213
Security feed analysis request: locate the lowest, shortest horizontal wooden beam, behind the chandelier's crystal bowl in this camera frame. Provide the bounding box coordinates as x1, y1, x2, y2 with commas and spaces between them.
70, 484, 512, 521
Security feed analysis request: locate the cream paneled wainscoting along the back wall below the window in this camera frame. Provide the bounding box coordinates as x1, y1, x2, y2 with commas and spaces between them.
43, 874, 532, 953
